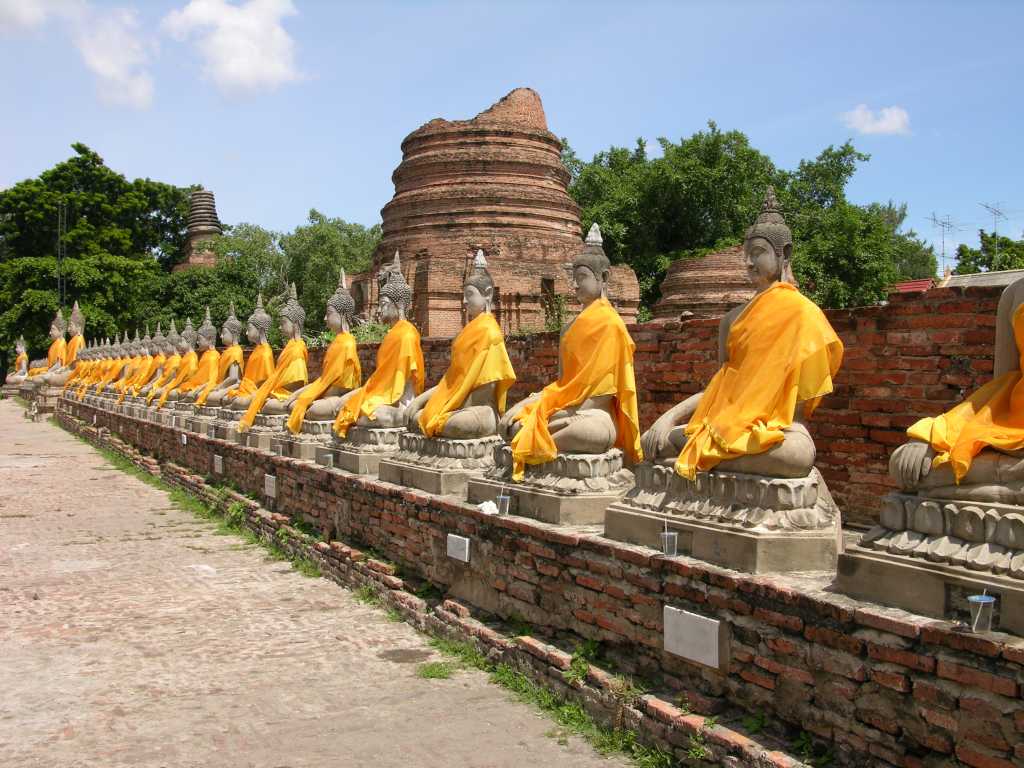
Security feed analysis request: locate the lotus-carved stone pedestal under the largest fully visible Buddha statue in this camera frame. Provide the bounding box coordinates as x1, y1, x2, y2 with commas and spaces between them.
604, 463, 841, 573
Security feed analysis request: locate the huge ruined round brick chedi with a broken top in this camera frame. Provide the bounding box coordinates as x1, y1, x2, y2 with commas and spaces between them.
352, 88, 639, 336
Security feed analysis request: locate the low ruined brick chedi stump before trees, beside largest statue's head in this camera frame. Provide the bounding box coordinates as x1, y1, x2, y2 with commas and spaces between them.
654, 246, 754, 319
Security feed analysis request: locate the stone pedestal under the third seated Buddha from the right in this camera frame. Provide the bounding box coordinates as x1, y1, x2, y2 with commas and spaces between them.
466, 444, 633, 525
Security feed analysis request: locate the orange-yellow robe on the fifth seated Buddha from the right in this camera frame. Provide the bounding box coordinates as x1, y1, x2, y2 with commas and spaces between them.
334, 321, 425, 437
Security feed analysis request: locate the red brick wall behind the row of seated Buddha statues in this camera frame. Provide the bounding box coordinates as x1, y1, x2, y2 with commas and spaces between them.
310, 288, 1000, 525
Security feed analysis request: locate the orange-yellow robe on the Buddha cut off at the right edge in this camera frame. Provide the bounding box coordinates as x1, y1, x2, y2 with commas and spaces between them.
906, 304, 1024, 484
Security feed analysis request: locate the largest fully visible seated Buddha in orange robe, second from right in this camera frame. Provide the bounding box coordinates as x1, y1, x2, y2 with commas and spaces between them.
641, 187, 843, 480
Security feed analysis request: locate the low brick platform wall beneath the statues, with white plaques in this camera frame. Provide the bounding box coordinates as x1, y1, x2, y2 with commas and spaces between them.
60, 403, 1024, 768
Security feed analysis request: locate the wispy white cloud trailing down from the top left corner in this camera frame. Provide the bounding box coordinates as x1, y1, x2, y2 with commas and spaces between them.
0, 0, 155, 110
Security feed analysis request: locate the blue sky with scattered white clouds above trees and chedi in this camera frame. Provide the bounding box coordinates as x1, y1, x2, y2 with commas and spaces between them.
0, 0, 1024, 274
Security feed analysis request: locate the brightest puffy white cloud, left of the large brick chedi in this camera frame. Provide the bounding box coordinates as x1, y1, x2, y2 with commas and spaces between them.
161, 0, 302, 95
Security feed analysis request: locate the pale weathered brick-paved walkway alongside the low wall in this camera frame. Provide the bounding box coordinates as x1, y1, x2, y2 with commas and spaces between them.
0, 400, 624, 768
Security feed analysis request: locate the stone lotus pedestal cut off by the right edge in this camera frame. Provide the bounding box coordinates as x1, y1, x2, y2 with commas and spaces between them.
836, 494, 1024, 635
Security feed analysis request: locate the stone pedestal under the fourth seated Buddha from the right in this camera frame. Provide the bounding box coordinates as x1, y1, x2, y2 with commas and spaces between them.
379, 431, 502, 499
